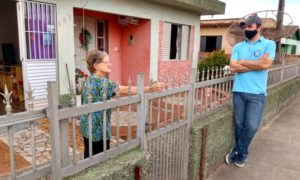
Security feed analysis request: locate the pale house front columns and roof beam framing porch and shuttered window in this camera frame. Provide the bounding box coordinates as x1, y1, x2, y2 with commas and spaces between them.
39, 0, 200, 94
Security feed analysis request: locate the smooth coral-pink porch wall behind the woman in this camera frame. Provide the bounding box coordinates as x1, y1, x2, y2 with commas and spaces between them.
74, 8, 151, 85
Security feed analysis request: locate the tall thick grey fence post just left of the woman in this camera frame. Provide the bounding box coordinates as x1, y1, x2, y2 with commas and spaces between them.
47, 82, 62, 180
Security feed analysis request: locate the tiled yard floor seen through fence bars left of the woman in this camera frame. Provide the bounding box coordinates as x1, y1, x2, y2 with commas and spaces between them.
0, 118, 83, 179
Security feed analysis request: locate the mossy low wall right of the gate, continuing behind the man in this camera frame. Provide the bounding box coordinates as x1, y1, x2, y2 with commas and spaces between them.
188, 78, 300, 180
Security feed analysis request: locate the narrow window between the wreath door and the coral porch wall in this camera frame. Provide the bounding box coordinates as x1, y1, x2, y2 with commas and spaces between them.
97, 21, 108, 52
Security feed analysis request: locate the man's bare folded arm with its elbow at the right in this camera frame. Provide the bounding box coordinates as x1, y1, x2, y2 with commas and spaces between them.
238, 53, 273, 70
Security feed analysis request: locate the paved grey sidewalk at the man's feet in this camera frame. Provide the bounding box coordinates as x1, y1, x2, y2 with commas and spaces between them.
208, 96, 300, 180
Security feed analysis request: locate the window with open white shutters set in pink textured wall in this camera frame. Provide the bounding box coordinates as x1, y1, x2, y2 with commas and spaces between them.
163, 23, 190, 60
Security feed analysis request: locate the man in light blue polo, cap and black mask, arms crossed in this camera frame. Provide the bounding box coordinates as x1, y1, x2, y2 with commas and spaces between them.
225, 15, 276, 167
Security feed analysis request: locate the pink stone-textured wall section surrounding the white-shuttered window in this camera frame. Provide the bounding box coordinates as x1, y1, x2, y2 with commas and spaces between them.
158, 21, 195, 87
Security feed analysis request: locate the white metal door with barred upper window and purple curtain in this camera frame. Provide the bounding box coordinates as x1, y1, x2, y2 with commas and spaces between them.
17, 0, 57, 110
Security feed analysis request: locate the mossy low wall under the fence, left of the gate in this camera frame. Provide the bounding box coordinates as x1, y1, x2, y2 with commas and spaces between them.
65, 149, 151, 180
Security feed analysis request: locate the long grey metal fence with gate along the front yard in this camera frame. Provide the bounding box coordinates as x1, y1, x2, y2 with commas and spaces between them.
0, 63, 300, 179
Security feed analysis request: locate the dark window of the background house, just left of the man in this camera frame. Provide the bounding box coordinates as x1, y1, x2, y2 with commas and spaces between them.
200, 36, 222, 52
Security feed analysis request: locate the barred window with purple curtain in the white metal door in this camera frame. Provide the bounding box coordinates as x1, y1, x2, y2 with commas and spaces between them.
24, 1, 56, 61
